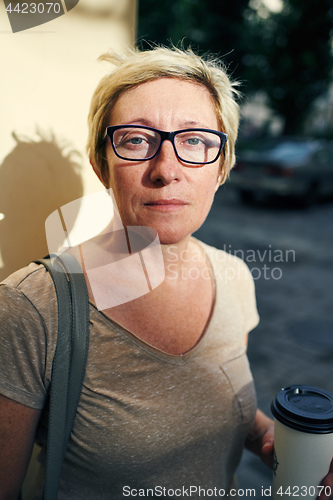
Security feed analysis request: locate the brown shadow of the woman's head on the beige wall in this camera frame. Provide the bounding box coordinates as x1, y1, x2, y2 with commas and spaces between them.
0, 131, 83, 281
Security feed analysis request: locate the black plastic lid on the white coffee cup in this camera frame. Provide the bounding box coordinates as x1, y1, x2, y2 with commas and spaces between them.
271, 385, 333, 434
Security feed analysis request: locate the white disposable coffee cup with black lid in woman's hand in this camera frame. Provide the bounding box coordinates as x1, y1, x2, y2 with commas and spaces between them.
271, 385, 333, 500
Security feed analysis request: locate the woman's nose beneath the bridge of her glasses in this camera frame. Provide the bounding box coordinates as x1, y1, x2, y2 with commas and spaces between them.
150, 140, 182, 185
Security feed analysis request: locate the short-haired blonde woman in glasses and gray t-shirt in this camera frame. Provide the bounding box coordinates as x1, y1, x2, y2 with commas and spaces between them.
0, 48, 330, 500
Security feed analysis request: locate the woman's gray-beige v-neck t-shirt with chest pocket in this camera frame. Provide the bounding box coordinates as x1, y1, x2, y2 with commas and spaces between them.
0, 240, 258, 500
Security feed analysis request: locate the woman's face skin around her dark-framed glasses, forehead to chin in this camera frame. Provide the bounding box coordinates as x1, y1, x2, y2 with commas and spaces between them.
97, 78, 220, 244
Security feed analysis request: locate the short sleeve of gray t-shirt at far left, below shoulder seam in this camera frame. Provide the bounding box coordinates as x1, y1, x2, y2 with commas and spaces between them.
0, 284, 47, 409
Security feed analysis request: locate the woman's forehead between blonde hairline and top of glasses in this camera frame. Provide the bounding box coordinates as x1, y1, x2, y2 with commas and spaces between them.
110, 78, 218, 129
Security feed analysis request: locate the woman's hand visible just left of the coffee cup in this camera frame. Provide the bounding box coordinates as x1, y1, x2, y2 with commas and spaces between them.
245, 410, 274, 469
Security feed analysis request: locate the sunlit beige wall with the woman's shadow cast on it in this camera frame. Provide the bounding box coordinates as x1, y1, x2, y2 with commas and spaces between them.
0, 0, 136, 279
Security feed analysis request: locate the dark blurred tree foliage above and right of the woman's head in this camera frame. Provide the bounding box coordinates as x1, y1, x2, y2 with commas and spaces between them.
138, 0, 333, 133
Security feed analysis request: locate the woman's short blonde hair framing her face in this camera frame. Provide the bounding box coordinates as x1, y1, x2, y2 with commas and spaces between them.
87, 46, 239, 184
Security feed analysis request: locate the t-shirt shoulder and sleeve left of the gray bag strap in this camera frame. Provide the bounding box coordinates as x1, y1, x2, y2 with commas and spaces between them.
0, 264, 58, 409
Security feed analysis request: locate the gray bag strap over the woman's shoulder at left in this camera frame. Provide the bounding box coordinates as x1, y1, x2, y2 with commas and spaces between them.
36, 253, 89, 500
